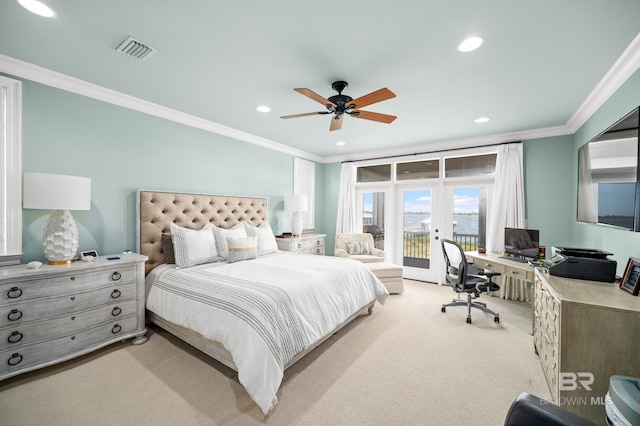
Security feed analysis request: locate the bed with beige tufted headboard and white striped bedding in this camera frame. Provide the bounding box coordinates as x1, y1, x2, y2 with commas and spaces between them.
137, 190, 388, 415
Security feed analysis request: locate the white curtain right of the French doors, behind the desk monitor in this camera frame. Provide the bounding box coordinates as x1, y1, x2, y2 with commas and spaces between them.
487, 142, 525, 252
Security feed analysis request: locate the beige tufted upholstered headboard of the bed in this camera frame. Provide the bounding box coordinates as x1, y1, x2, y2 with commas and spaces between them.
137, 190, 268, 274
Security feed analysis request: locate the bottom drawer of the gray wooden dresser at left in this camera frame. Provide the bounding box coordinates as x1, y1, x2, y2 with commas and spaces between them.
0, 316, 137, 375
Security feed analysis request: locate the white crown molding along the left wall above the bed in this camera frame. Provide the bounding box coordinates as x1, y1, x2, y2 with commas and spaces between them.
0, 54, 322, 162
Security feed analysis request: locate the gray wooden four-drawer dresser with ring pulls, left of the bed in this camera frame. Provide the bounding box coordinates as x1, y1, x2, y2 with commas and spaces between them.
0, 253, 147, 380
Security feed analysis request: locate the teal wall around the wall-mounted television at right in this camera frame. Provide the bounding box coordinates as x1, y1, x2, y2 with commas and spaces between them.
572, 70, 640, 275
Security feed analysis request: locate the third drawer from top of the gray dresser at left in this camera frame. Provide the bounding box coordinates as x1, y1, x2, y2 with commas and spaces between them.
0, 300, 138, 351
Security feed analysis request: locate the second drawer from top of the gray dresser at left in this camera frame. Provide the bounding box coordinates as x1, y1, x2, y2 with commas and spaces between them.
0, 283, 137, 328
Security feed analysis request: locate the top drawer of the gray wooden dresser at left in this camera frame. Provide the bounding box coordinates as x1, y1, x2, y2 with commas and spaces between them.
0, 266, 136, 305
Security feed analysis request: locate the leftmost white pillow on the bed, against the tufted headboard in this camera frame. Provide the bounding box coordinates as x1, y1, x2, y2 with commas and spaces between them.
169, 223, 218, 268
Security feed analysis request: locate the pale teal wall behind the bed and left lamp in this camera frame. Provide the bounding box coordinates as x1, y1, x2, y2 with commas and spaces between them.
16, 76, 325, 262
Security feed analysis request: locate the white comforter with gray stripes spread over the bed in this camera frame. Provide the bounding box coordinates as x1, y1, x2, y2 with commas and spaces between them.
147, 252, 388, 414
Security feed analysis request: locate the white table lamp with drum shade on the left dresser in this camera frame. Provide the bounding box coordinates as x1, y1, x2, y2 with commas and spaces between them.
22, 173, 91, 265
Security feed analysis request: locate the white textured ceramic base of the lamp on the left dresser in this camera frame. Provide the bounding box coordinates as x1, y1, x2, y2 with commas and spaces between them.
42, 210, 78, 265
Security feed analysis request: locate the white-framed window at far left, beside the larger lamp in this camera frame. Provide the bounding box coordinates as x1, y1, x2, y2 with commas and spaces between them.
0, 76, 22, 265
